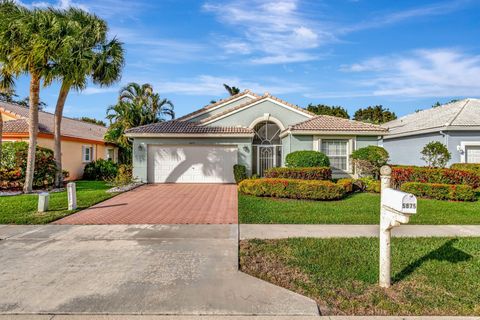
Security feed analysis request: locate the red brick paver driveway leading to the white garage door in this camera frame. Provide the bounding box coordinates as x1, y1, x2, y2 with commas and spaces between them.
54, 184, 238, 224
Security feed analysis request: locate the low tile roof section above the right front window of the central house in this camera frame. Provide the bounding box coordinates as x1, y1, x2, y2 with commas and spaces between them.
290, 115, 387, 132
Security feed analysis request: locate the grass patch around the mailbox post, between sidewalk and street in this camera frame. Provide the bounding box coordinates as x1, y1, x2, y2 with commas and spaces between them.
240, 238, 480, 316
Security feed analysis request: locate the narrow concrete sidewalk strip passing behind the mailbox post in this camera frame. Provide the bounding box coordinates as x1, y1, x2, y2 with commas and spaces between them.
240, 224, 480, 240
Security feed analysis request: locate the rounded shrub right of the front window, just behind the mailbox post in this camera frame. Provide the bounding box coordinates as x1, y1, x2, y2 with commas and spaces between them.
352, 146, 389, 178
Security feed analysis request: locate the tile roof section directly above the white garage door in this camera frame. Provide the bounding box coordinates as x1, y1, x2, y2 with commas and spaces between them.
126, 120, 253, 134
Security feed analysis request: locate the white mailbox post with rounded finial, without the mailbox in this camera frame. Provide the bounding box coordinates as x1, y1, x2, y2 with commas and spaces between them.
379, 166, 392, 288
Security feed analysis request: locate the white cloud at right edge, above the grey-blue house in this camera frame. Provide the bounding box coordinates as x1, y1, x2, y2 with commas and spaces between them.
341, 49, 480, 97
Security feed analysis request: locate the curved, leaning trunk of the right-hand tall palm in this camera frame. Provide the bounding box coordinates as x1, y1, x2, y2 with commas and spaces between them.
53, 82, 70, 188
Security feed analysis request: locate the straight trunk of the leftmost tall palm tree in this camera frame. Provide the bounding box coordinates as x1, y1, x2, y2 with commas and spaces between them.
23, 72, 40, 193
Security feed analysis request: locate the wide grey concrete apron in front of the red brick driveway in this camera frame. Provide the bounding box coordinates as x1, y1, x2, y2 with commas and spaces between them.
0, 225, 318, 320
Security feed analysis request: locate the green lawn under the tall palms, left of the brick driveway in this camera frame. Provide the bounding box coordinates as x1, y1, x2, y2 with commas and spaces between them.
0, 181, 115, 224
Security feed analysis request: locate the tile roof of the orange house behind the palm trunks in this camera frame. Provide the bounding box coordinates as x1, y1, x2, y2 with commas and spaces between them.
0, 102, 107, 141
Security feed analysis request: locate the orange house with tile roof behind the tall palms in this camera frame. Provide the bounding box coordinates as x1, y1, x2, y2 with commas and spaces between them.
0, 102, 118, 180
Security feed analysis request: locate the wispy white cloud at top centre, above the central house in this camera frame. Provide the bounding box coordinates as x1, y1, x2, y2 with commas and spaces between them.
203, 0, 335, 64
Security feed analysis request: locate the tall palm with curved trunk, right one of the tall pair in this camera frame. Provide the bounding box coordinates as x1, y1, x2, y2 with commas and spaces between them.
46, 8, 124, 187
